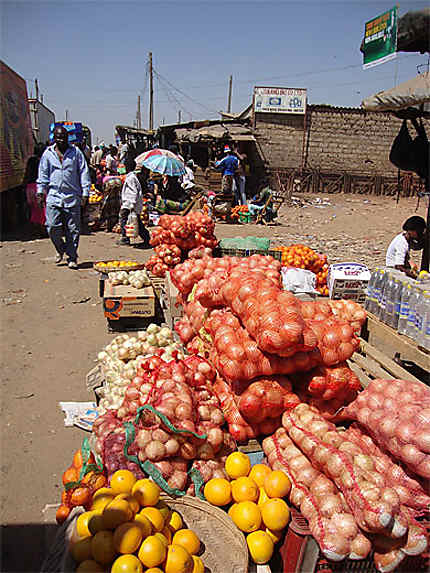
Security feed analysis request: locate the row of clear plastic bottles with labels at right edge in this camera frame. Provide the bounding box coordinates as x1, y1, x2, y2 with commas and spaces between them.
365, 267, 430, 350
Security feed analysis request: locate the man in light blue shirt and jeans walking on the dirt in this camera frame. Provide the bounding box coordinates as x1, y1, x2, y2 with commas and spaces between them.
37, 126, 91, 269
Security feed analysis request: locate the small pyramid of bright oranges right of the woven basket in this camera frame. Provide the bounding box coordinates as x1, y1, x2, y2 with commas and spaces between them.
204, 452, 291, 565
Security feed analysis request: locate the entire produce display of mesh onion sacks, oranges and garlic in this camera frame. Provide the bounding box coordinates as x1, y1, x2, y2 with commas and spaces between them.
43, 213, 430, 573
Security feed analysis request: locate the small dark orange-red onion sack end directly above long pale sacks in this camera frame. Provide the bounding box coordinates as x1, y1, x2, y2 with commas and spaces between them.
238, 376, 300, 424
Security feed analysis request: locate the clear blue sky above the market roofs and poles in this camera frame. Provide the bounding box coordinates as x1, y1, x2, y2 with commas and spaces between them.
1, 0, 428, 143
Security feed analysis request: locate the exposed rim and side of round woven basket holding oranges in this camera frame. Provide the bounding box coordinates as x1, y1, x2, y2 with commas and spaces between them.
161, 494, 248, 573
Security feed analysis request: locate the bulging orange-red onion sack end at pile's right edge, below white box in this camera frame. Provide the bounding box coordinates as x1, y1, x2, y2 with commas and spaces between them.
306, 319, 360, 366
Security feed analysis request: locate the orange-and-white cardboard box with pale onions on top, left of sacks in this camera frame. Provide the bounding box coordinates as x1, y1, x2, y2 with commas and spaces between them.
103, 280, 155, 320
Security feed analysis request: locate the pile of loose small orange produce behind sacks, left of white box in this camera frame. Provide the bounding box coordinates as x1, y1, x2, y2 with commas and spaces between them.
273, 245, 329, 296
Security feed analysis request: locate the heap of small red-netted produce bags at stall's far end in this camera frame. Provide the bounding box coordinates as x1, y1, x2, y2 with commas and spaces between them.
145, 211, 218, 277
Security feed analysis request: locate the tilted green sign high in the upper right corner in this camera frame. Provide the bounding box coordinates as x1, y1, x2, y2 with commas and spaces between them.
363, 6, 398, 70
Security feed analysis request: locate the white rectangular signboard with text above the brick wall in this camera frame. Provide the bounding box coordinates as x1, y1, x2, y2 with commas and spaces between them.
254, 87, 306, 114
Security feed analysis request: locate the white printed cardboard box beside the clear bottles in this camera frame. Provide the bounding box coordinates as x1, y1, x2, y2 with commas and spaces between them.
327, 262, 370, 302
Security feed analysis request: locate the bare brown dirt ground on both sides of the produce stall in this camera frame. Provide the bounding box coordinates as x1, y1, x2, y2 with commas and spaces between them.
0, 195, 426, 571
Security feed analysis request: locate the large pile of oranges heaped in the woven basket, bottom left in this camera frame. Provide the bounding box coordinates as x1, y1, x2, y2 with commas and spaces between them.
70, 470, 204, 573
